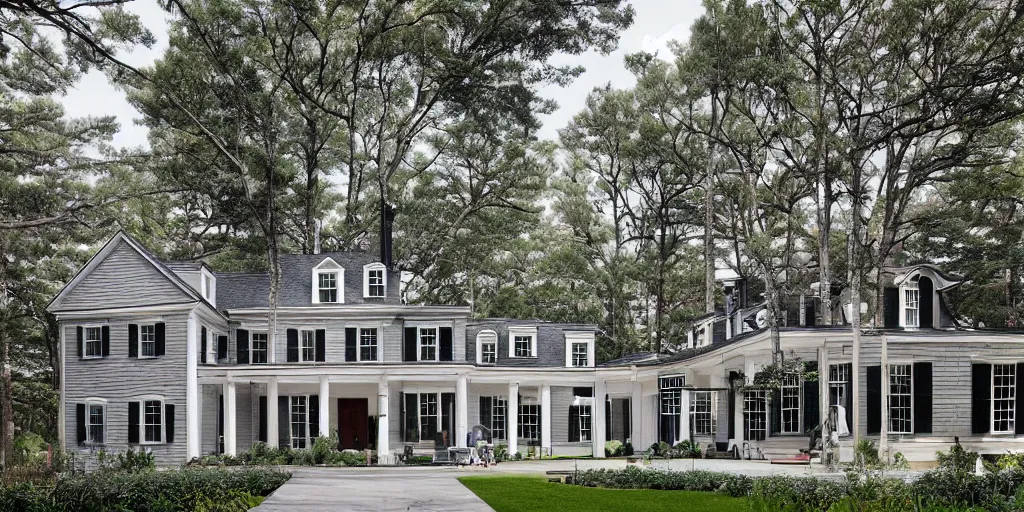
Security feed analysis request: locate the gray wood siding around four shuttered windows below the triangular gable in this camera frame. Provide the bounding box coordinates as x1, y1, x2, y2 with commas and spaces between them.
62, 313, 187, 465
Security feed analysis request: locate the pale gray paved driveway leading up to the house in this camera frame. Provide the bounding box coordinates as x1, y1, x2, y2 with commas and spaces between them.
255, 459, 847, 512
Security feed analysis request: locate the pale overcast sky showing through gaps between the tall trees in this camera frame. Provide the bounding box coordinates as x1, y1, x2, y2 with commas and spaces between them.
63, 0, 703, 147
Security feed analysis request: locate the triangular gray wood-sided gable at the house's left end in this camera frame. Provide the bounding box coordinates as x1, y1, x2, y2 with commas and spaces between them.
55, 241, 193, 312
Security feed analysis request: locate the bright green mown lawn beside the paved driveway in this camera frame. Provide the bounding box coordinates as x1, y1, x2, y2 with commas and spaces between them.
459, 476, 748, 512
